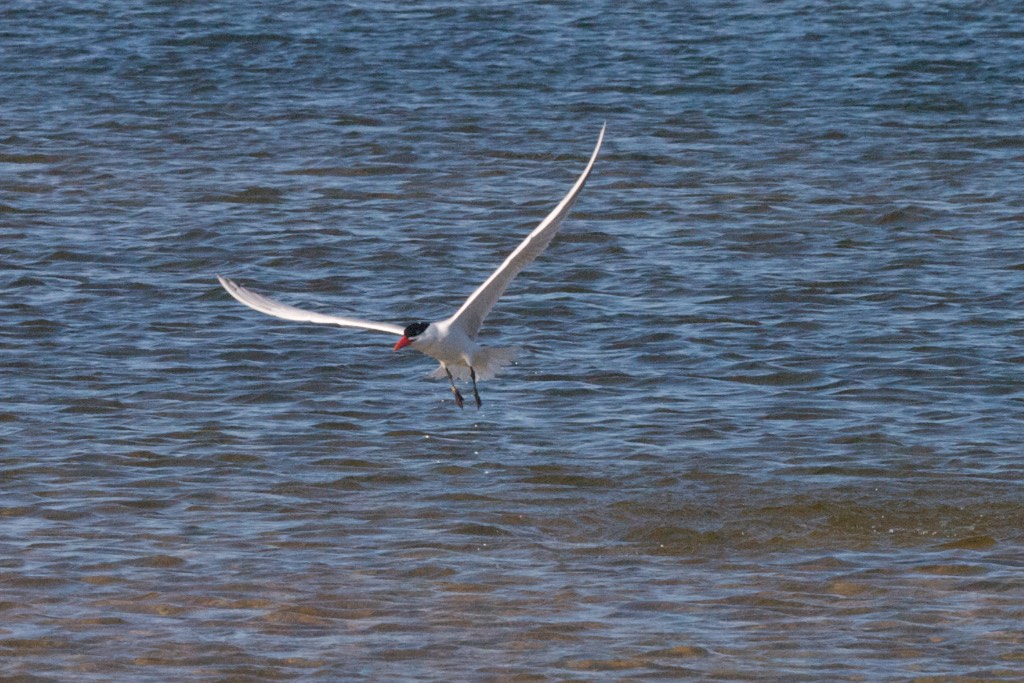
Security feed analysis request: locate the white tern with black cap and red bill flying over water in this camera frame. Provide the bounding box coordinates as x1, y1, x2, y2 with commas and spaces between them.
217, 126, 605, 409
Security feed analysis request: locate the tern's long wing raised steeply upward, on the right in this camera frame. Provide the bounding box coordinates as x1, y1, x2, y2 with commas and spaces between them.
449, 125, 606, 339
